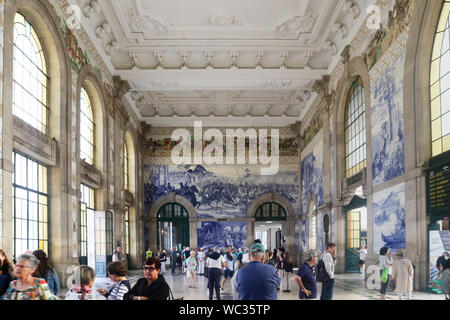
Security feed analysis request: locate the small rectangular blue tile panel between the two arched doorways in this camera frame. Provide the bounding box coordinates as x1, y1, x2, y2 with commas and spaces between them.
197, 222, 248, 248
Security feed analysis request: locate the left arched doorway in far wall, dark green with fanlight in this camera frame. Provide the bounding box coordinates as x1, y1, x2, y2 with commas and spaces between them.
157, 202, 189, 250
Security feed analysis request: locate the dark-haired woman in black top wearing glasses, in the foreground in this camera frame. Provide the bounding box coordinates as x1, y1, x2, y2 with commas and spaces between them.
123, 257, 170, 300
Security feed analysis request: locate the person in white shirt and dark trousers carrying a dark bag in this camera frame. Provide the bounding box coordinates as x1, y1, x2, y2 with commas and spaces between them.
317, 242, 336, 300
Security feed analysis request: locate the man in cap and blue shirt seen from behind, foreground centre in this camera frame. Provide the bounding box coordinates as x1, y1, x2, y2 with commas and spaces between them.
236, 243, 280, 300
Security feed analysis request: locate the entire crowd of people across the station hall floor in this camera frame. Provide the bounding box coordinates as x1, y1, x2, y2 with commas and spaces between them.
0, 244, 450, 300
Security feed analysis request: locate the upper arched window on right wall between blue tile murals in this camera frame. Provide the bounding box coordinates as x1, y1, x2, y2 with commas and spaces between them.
345, 77, 366, 178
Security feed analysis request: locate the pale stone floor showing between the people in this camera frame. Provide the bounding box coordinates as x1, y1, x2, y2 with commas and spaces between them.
59, 270, 444, 300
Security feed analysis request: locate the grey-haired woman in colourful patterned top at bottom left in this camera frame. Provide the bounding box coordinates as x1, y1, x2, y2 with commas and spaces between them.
2, 253, 57, 300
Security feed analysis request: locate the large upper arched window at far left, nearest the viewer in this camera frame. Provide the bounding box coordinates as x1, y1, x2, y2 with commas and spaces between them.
12, 13, 50, 134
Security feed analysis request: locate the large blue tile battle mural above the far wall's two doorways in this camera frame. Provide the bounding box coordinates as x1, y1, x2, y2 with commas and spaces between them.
144, 165, 298, 219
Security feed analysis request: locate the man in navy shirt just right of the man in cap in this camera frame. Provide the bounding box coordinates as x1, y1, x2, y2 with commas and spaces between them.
295, 250, 317, 300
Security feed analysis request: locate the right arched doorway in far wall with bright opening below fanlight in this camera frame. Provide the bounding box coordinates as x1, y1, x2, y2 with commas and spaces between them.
255, 202, 287, 250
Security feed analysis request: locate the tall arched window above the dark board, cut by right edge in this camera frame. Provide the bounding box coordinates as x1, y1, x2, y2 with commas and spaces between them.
430, 0, 450, 157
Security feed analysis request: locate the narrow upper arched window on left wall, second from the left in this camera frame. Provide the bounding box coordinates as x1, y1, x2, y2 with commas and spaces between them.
80, 87, 95, 165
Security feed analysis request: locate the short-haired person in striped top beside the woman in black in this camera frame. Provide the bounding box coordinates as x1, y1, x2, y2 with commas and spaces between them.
97, 261, 131, 300
